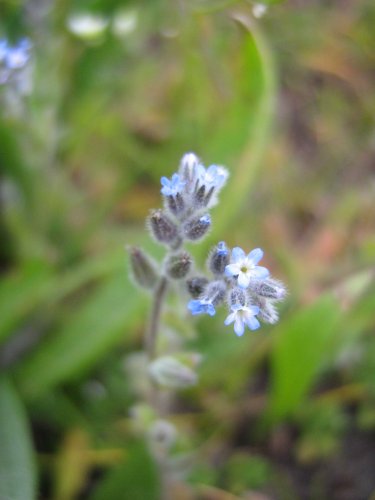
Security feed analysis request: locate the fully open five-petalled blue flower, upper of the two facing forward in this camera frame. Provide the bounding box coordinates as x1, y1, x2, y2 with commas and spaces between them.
225, 247, 270, 288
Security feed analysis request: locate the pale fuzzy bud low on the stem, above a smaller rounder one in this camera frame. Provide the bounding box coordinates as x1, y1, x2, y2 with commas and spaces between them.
148, 356, 198, 389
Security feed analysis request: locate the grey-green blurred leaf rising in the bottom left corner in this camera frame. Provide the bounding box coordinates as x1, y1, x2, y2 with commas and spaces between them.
0, 377, 36, 500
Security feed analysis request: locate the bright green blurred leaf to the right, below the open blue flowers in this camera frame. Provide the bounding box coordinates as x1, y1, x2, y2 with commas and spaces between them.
270, 294, 340, 420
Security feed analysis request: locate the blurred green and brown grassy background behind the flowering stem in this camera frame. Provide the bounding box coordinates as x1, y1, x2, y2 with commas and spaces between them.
0, 0, 375, 500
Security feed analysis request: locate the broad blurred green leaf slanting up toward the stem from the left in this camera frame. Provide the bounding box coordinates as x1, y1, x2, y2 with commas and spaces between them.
17, 271, 147, 397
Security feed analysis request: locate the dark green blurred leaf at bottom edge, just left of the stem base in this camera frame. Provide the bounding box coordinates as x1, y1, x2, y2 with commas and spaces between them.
92, 442, 161, 500
